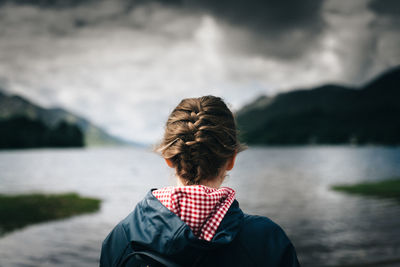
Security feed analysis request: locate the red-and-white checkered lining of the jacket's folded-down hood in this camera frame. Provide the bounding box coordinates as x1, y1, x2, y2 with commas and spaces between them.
152, 185, 235, 241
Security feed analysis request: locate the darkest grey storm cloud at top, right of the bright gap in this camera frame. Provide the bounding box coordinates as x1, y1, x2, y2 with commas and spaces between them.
148, 0, 324, 59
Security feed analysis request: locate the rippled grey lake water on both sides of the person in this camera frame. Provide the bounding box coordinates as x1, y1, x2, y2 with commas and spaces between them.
0, 146, 400, 266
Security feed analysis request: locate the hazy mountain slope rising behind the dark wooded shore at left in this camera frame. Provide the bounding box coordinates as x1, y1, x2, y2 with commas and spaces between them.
0, 90, 127, 146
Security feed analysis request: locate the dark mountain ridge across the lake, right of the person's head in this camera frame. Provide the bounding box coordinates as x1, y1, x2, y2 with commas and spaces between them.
236, 66, 400, 145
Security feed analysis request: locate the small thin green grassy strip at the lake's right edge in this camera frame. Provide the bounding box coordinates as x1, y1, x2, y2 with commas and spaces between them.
332, 177, 400, 200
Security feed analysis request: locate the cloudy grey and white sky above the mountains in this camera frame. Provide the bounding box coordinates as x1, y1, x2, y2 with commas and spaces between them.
0, 0, 400, 143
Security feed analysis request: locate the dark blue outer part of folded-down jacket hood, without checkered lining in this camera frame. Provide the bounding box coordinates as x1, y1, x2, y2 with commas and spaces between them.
122, 189, 243, 261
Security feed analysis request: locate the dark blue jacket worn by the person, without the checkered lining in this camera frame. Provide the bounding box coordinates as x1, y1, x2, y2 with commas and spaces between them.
100, 189, 299, 267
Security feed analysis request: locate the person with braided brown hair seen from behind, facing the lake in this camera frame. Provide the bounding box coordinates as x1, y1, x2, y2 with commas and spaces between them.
100, 96, 299, 267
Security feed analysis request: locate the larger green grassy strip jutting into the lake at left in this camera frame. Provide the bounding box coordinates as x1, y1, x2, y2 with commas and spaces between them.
0, 193, 101, 235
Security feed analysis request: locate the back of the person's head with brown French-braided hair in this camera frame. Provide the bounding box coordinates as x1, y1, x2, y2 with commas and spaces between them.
158, 96, 243, 185
